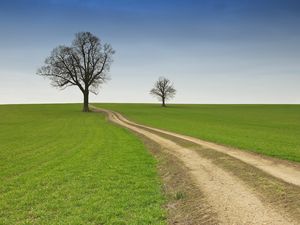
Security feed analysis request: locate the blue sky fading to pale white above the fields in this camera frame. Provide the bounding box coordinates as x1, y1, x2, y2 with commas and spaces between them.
0, 0, 300, 104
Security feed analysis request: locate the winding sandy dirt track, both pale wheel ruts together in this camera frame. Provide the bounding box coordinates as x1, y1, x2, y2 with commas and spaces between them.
95, 108, 300, 225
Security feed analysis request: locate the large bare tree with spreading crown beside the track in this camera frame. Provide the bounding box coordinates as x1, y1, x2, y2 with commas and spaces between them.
37, 32, 115, 112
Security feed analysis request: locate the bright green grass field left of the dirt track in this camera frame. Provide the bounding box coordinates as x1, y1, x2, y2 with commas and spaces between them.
0, 104, 166, 225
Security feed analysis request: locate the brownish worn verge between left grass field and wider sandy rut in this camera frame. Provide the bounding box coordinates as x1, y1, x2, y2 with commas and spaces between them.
137, 133, 219, 225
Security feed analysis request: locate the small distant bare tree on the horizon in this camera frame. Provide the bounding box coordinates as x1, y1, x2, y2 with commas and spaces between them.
150, 77, 176, 107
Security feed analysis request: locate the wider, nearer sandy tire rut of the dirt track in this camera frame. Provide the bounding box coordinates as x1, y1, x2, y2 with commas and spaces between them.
93, 109, 297, 225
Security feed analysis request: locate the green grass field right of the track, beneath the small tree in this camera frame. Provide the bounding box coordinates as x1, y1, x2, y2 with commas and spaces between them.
95, 104, 300, 162
